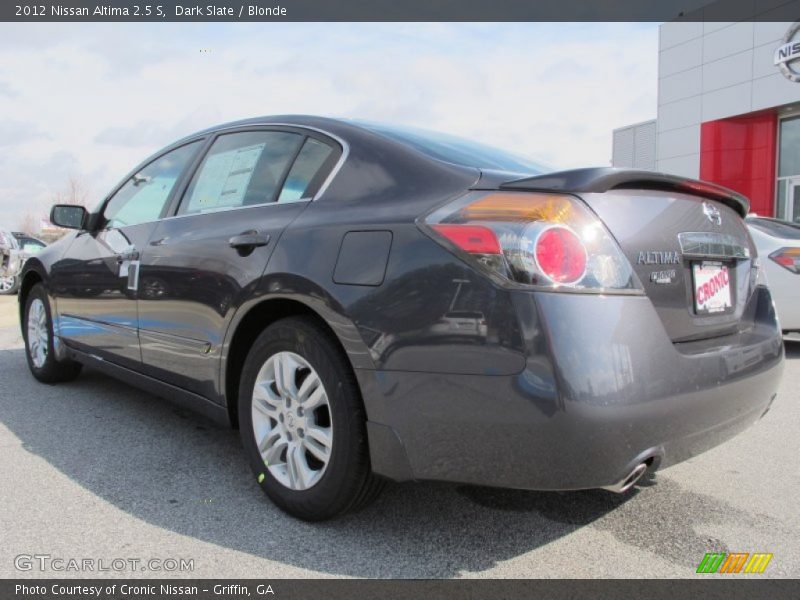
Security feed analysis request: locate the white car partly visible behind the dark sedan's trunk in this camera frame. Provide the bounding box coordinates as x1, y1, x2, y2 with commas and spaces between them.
747, 217, 800, 333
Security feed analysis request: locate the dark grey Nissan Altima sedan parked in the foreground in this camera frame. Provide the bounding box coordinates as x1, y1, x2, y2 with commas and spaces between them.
19, 116, 783, 520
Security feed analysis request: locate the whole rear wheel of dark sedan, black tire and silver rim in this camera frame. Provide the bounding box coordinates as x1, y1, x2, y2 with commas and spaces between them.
238, 317, 384, 521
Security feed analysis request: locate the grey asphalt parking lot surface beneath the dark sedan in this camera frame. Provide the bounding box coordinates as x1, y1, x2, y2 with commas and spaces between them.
0, 297, 800, 578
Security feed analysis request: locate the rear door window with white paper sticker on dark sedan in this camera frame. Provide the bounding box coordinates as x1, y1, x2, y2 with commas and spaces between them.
178, 131, 303, 214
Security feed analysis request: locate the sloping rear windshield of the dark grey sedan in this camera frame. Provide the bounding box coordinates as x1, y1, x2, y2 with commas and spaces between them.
357, 121, 553, 175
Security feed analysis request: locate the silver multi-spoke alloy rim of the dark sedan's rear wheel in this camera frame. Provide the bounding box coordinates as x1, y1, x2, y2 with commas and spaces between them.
251, 352, 333, 491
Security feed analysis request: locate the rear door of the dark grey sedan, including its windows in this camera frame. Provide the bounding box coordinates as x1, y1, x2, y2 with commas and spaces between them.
139, 128, 341, 397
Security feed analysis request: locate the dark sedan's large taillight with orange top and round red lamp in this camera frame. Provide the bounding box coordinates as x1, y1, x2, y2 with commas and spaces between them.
422, 192, 641, 292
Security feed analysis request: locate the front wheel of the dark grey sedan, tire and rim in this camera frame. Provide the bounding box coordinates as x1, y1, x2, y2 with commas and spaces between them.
22, 283, 82, 383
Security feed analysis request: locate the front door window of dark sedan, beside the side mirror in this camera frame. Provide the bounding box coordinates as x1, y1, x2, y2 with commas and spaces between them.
103, 142, 200, 228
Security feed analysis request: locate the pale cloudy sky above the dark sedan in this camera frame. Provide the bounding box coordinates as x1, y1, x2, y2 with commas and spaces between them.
0, 23, 658, 229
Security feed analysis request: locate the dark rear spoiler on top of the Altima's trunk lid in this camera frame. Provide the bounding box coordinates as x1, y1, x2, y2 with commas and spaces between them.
500, 167, 750, 217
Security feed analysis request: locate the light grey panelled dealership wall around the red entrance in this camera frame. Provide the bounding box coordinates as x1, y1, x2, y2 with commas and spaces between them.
652, 11, 800, 177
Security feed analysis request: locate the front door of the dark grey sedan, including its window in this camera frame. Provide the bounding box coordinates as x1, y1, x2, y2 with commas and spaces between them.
51, 141, 201, 366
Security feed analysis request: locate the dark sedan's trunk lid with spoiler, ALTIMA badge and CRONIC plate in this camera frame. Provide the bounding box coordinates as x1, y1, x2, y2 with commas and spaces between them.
490, 169, 755, 342
